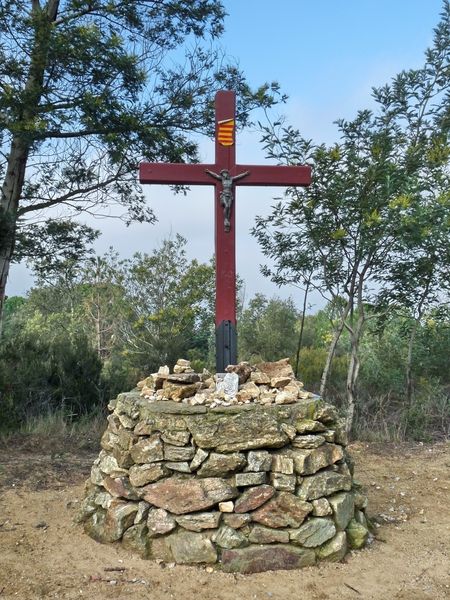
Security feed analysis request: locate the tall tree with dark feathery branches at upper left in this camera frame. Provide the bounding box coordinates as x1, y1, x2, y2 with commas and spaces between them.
0, 0, 284, 328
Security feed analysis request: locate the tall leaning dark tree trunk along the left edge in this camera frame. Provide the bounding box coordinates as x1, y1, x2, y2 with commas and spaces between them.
0, 0, 60, 334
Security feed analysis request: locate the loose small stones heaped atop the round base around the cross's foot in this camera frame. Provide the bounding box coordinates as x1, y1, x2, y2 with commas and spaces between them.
137, 358, 313, 408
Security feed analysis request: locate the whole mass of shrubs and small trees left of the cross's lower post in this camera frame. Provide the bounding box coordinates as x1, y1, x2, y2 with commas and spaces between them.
0, 236, 214, 427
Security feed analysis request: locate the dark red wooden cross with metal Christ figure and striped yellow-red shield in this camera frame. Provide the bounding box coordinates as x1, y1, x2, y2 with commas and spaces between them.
139, 91, 311, 373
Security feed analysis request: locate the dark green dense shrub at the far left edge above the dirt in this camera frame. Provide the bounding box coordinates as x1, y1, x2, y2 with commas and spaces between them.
0, 305, 101, 427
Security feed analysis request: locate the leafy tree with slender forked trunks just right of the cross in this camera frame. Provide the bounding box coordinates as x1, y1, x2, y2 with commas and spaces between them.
254, 2, 450, 428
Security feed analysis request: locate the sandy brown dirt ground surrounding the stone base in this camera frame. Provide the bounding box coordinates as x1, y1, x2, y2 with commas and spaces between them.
0, 443, 450, 600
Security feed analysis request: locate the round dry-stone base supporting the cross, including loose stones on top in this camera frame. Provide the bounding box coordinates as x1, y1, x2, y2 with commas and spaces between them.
79, 359, 371, 573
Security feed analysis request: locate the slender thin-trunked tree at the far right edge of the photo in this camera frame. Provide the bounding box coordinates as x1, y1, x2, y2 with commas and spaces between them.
374, 1, 450, 406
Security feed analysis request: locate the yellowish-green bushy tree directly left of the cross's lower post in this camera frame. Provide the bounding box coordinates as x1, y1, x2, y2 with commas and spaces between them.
116, 235, 214, 372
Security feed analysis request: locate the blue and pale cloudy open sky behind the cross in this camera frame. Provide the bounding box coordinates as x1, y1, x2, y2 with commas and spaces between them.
7, 0, 442, 310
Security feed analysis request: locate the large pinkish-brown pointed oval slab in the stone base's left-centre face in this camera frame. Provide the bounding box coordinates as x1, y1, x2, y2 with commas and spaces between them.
142, 477, 238, 515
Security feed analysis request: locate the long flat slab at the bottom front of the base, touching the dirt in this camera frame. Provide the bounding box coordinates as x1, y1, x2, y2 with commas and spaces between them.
222, 544, 316, 574
